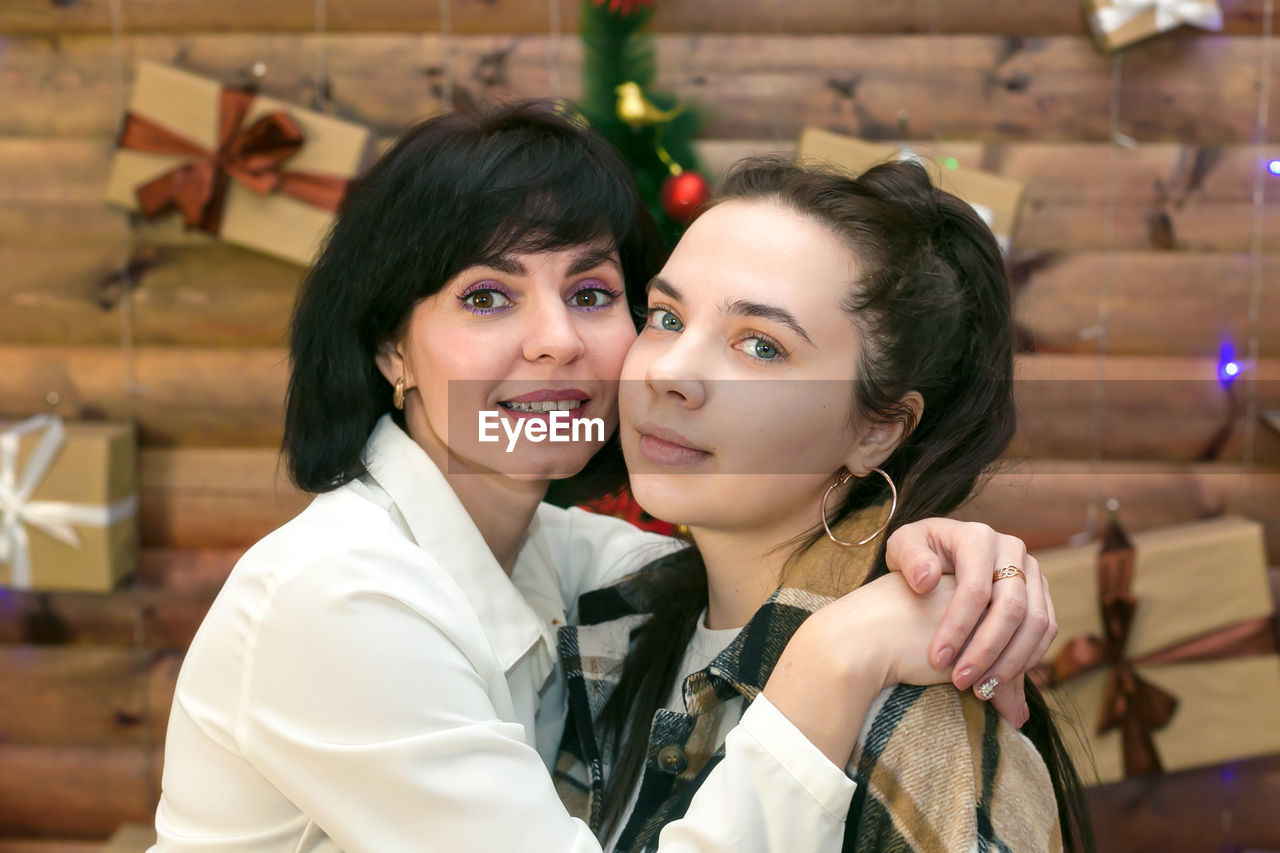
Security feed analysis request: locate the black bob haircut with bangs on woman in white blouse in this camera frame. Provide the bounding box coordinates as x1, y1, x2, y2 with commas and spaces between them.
283, 101, 666, 503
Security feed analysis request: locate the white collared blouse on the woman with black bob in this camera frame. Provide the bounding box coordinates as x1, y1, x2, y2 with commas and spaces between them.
152, 416, 854, 853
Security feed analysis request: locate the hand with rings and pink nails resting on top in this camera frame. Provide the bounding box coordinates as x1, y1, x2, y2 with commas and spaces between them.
886, 519, 1057, 726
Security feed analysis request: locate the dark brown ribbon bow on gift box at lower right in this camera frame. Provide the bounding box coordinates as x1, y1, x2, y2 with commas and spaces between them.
1036, 578, 1276, 776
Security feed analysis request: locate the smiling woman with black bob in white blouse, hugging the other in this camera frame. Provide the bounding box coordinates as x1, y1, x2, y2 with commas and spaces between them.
155, 105, 1059, 853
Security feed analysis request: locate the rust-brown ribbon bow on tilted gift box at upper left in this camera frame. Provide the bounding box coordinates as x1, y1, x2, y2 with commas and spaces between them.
119, 88, 351, 234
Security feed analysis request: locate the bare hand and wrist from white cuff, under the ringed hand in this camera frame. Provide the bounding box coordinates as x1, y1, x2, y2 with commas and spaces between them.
764, 574, 955, 767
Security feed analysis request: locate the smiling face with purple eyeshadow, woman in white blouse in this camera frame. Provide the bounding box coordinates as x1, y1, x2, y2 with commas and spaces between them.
394, 240, 635, 480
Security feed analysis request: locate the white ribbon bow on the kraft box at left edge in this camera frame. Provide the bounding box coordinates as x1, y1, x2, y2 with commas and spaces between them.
0, 415, 138, 589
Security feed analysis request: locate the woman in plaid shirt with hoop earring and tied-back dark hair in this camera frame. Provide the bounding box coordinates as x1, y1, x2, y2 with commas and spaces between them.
559, 159, 1092, 852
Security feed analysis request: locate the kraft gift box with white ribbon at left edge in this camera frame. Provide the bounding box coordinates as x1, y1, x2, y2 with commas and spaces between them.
0, 415, 138, 592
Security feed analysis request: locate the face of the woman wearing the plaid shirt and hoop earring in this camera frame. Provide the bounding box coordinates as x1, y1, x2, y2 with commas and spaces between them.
620, 200, 880, 530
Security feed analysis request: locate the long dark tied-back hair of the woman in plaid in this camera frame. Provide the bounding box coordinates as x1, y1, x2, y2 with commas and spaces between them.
599, 158, 1093, 849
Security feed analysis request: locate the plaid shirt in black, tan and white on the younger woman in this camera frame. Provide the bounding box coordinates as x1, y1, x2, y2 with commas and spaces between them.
556, 507, 1062, 852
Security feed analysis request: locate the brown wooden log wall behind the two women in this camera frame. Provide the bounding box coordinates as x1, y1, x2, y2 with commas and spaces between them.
0, 0, 1280, 853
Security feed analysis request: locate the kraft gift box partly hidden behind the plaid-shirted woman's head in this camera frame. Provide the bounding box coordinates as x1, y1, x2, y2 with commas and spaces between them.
796, 128, 1025, 255
